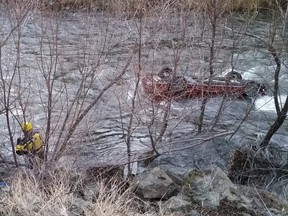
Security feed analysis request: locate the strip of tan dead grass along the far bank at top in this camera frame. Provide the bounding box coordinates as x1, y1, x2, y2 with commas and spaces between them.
20, 0, 286, 13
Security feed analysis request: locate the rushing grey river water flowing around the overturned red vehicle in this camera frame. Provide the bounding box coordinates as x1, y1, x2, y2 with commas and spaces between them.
0, 7, 288, 171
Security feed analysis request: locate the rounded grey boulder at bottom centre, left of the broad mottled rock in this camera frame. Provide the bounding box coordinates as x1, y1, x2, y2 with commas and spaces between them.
135, 167, 179, 200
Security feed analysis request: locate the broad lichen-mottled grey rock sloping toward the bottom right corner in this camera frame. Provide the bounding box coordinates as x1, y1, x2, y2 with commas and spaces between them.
182, 166, 288, 216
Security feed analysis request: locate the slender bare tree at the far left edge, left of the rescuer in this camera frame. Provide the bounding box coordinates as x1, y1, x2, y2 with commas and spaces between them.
0, 1, 37, 166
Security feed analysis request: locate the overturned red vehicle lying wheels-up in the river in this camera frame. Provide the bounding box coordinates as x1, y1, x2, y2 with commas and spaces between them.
141, 67, 267, 102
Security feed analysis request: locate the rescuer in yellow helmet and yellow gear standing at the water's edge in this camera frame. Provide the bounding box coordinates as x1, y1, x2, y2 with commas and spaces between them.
16, 122, 44, 169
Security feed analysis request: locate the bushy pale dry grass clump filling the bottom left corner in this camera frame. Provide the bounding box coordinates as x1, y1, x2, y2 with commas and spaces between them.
1, 170, 71, 216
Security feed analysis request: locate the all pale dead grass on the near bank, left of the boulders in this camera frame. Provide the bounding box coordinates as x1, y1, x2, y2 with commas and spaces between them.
0, 169, 156, 216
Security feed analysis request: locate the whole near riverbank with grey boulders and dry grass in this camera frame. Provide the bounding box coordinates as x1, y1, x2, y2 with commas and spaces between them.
0, 146, 288, 216
